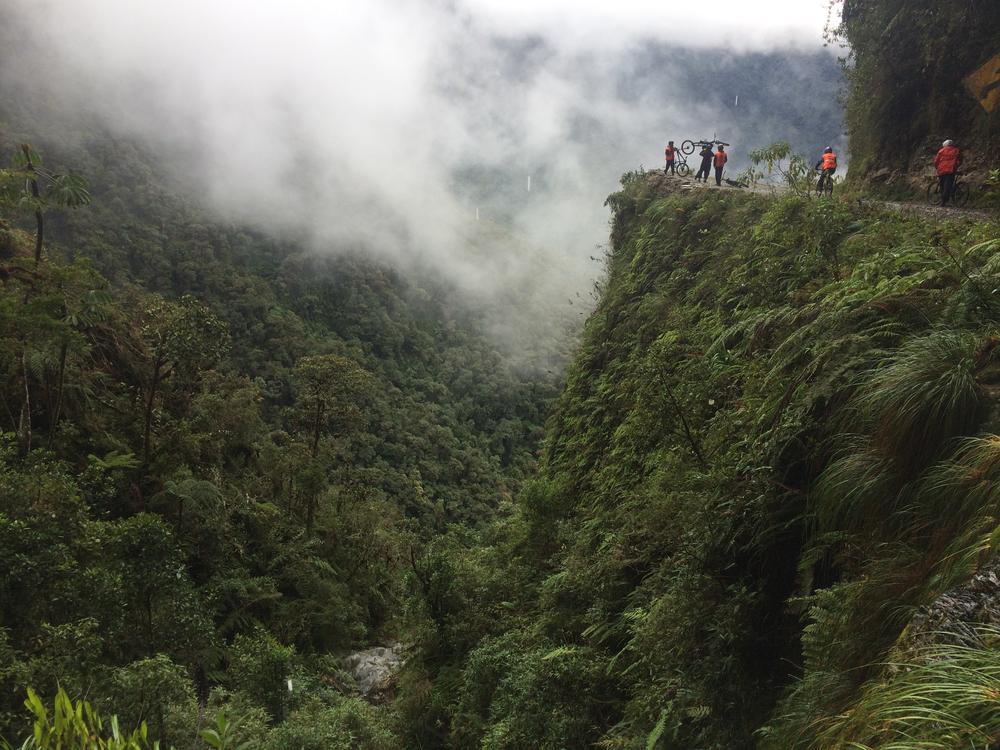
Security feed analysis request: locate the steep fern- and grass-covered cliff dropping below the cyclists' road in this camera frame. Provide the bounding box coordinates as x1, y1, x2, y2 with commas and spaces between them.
402, 174, 1000, 750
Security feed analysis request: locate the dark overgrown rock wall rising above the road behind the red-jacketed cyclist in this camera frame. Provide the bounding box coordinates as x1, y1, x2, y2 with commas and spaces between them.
841, 0, 1000, 188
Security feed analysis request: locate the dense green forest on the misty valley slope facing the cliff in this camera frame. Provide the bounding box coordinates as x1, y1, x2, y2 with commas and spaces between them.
0, 128, 562, 747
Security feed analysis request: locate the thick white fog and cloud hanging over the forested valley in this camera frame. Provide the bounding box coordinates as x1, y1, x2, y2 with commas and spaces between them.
0, 0, 841, 358
